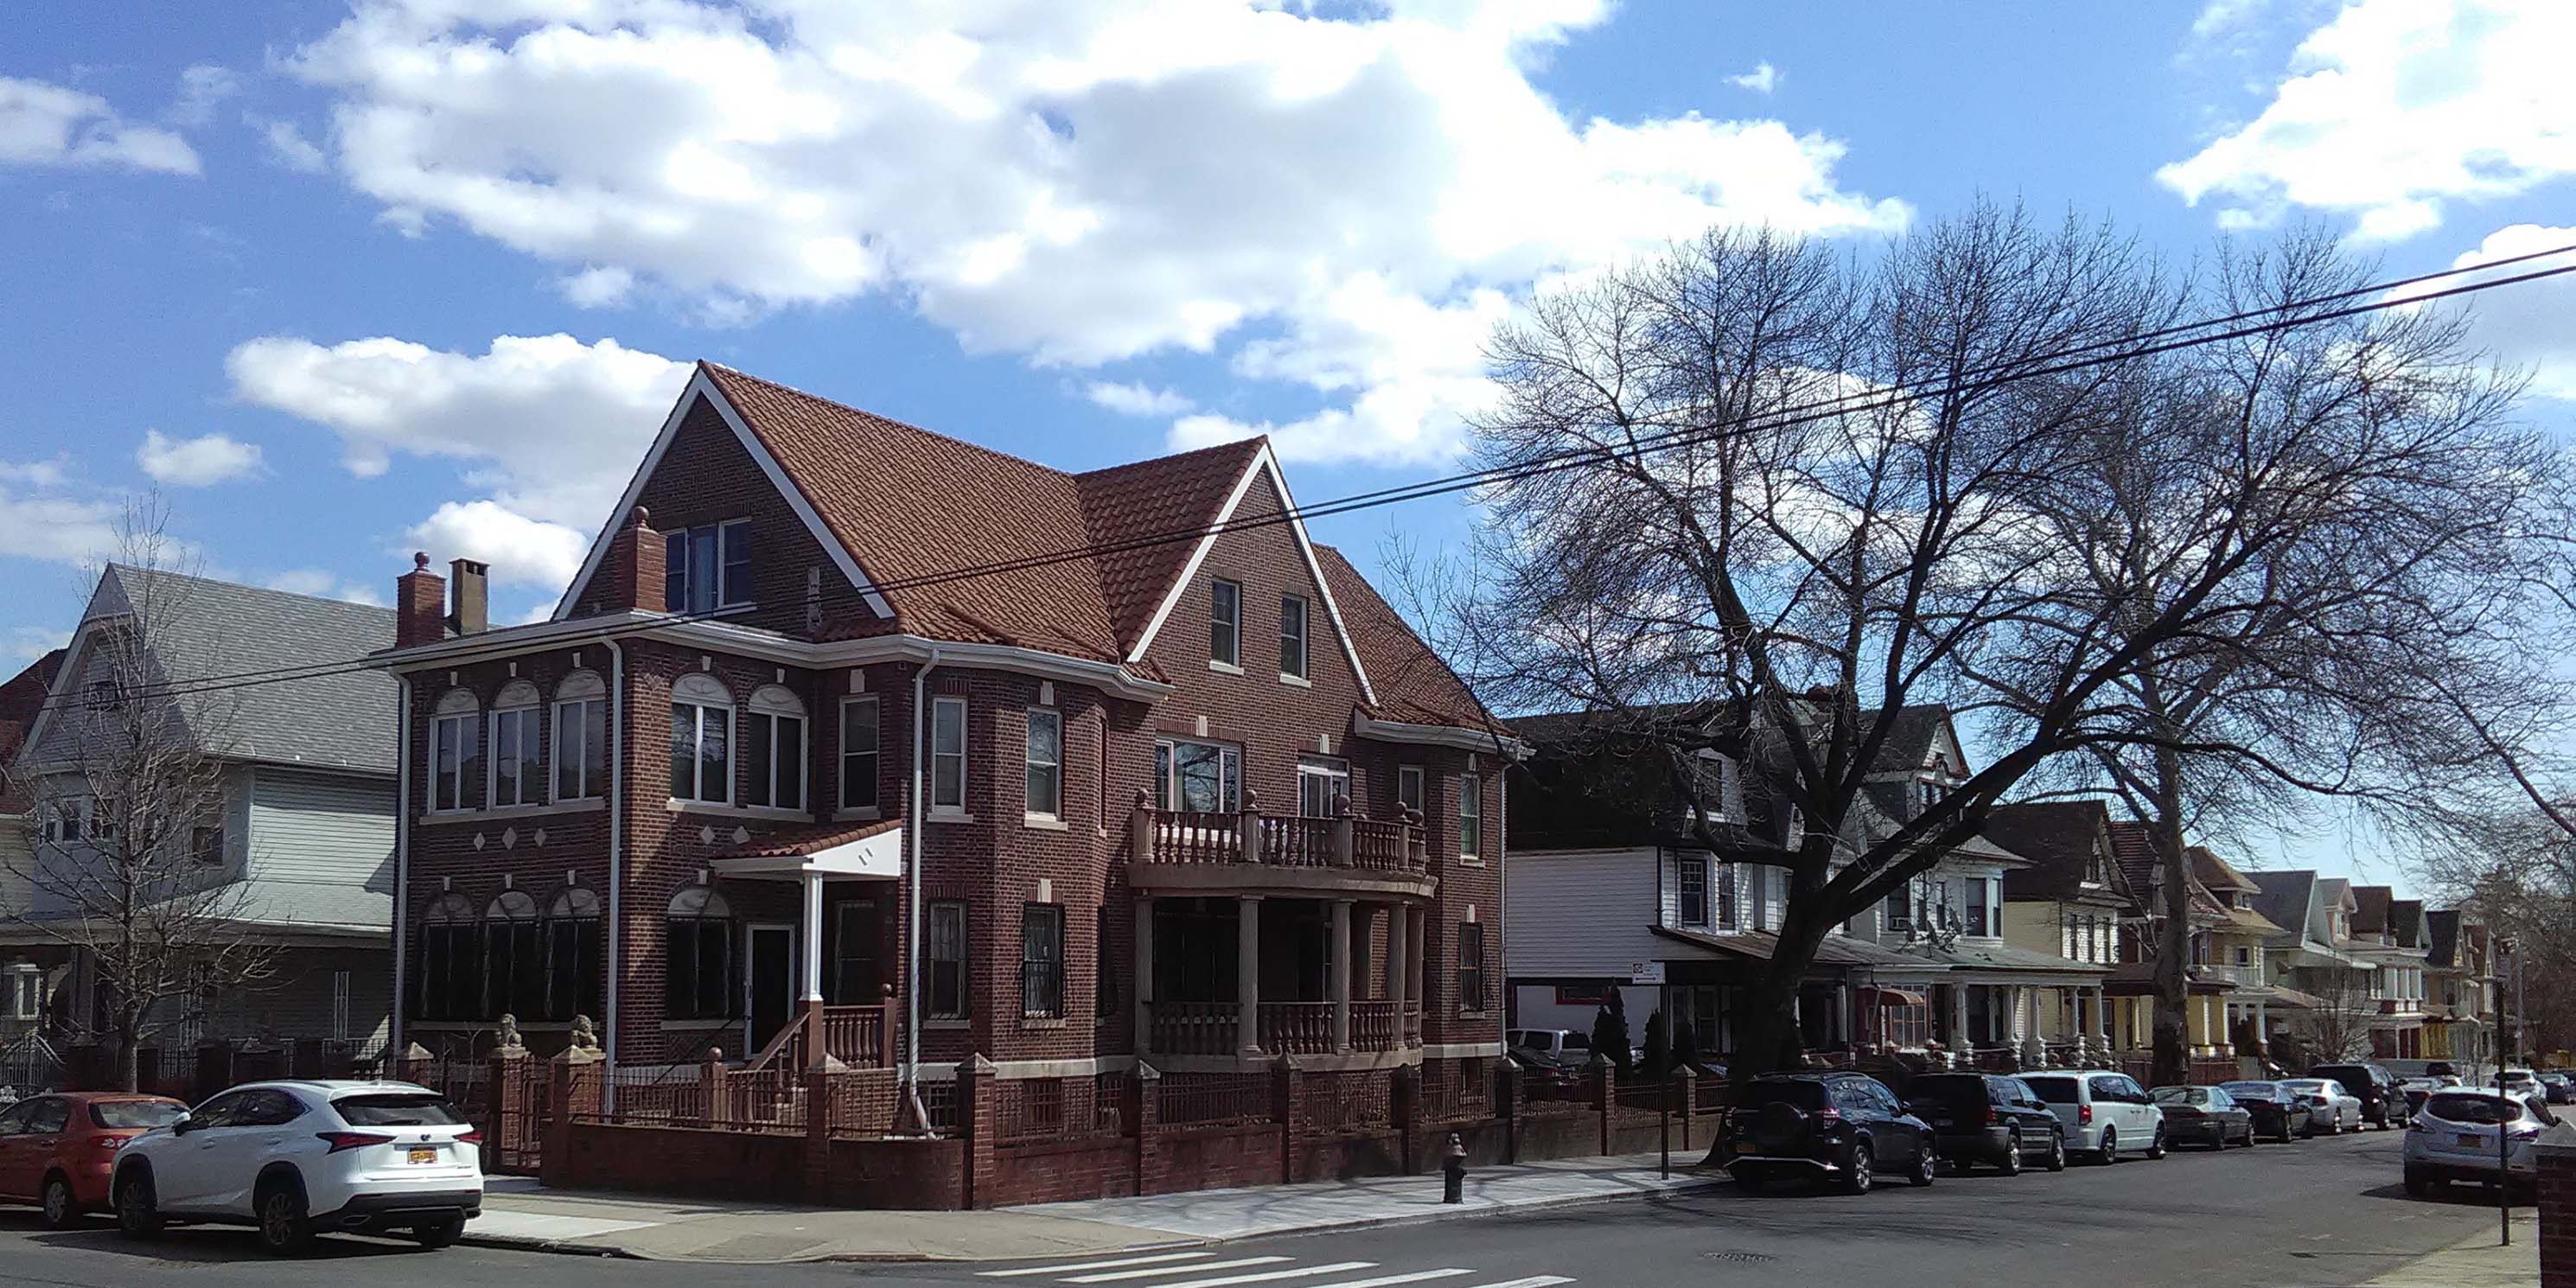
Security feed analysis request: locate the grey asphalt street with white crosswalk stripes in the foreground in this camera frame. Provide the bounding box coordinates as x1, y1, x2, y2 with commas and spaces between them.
0, 1131, 2496, 1288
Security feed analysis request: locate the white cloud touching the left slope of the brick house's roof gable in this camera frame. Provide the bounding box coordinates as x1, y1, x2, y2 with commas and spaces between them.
224, 335, 691, 584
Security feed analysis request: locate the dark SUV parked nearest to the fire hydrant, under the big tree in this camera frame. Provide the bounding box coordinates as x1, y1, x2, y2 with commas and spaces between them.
1726, 1074, 1940, 1196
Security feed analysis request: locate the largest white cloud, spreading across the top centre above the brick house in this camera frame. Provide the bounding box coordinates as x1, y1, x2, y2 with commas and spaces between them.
289, 0, 1909, 458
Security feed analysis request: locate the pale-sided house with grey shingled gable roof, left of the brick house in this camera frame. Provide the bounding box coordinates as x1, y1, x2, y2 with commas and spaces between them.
0, 564, 397, 1090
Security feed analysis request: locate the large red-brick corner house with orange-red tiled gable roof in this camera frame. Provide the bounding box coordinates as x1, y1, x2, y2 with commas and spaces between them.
376, 363, 1512, 1123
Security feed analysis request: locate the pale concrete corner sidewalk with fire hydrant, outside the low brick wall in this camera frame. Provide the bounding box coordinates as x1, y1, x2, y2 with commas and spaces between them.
466, 1154, 1724, 1265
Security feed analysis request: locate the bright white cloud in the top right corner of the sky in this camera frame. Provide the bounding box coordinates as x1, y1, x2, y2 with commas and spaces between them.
2156, 0, 2576, 242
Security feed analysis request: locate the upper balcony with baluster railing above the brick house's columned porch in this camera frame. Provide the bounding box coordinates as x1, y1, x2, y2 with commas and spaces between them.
1128, 791, 1438, 899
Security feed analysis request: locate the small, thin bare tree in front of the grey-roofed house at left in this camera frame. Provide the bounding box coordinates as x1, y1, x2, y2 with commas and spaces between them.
3, 502, 276, 1090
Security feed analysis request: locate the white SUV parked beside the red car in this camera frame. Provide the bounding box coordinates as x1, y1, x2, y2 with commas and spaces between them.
111, 1082, 481, 1252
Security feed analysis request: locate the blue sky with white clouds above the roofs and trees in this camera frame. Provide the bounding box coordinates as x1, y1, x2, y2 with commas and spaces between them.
0, 0, 2576, 896
